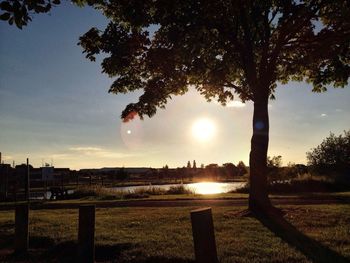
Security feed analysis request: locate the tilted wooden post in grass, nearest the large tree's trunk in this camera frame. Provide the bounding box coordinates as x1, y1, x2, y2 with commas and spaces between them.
191, 208, 219, 263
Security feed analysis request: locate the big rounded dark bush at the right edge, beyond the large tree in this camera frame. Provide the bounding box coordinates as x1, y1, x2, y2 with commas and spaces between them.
306, 130, 350, 178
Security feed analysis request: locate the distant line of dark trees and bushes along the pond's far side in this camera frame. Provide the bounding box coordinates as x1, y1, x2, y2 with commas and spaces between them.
102, 130, 350, 184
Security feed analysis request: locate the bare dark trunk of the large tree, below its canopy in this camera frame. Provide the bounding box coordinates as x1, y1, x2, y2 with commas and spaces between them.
249, 96, 272, 212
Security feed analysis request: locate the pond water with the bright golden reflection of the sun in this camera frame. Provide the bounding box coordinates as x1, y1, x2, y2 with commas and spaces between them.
113, 182, 246, 194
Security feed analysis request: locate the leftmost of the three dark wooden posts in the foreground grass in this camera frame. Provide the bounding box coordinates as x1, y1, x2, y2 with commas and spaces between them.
15, 204, 29, 254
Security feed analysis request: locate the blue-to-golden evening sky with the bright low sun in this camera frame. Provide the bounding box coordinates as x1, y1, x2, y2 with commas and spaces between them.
0, 2, 350, 169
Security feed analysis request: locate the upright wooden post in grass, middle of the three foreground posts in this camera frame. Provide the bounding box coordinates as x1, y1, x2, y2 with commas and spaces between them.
78, 205, 95, 263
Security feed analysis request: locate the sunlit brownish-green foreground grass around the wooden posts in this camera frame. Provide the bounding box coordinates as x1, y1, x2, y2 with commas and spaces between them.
0, 204, 350, 262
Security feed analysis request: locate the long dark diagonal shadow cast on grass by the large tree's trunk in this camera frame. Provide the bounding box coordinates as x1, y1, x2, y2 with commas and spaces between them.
255, 210, 350, 263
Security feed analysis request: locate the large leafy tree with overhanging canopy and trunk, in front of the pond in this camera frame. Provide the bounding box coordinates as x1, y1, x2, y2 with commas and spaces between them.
4, 0, 350, 214
